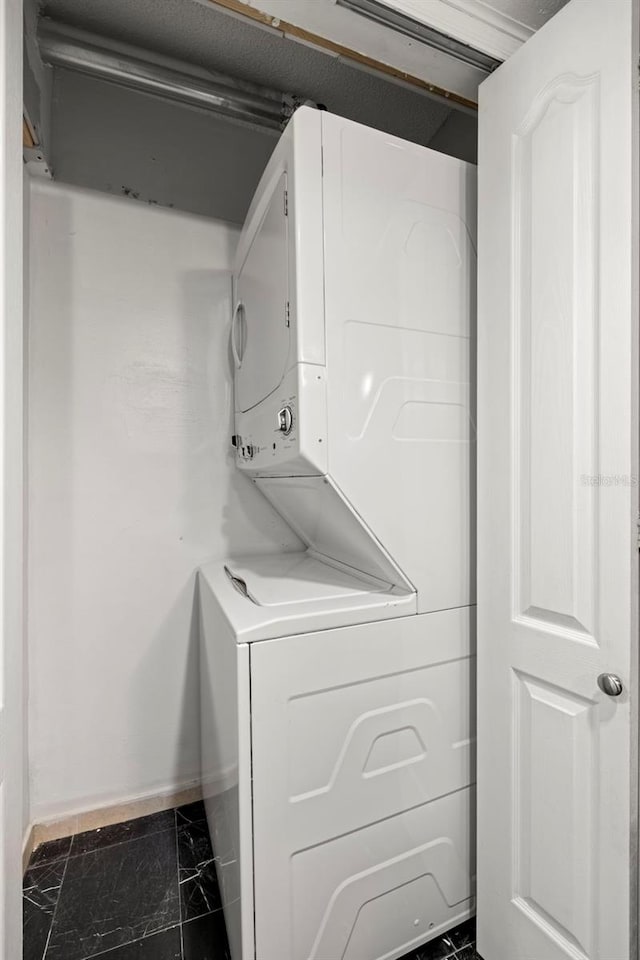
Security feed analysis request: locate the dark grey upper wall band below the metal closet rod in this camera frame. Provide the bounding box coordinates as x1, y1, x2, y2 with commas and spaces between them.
49, 70, 278, 224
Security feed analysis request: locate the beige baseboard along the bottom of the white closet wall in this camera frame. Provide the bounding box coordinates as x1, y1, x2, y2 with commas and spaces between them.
22, 780, 202, 868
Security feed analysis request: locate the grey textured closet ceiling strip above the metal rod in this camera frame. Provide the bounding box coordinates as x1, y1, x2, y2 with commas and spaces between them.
42, 0, 451, 145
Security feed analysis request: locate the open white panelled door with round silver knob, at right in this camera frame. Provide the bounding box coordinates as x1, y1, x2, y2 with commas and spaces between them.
478, 0, 638, 960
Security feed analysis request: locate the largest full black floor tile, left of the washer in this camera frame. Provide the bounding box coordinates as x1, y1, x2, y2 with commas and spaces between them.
47, 830, 180, 960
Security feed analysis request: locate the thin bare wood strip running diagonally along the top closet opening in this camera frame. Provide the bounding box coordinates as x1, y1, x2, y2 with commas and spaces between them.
208, 0, 478, 110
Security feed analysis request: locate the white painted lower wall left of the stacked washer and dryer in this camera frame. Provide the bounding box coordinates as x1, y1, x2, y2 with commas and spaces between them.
29, 182, 299, 820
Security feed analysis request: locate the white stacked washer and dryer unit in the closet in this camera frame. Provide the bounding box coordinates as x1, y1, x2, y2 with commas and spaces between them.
200, 107, 476, 960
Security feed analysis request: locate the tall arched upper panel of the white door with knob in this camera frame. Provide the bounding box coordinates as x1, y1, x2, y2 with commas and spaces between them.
511, 73, 600, 643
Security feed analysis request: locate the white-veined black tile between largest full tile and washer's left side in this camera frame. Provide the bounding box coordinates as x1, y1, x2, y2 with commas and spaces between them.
178, 821, 222, 921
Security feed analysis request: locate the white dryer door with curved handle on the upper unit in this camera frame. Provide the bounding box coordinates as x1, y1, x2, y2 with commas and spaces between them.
231, 173, 290, 412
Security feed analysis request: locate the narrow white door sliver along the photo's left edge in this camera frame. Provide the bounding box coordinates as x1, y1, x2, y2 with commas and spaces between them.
0, 0, 23, 960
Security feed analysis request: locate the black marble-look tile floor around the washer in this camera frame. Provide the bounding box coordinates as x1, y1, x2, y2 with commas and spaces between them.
24, 803, 477, 960
